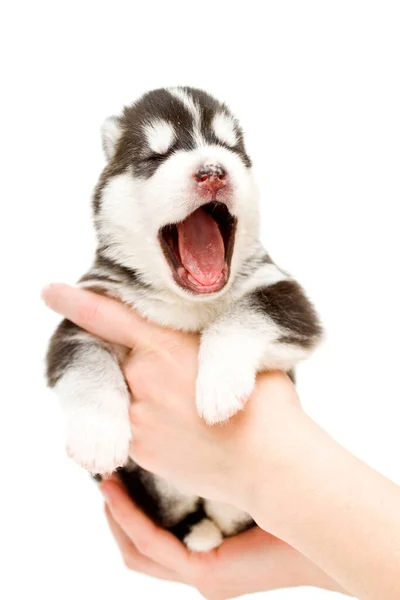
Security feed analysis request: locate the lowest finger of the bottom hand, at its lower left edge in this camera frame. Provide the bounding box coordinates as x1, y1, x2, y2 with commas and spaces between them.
105, 505, 182, 583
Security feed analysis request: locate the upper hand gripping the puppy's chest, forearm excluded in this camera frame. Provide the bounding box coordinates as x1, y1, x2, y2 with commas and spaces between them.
43, 285, 301, 514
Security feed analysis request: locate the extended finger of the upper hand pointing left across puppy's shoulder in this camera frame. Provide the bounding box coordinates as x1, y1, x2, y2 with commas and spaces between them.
42, 283, 174, 348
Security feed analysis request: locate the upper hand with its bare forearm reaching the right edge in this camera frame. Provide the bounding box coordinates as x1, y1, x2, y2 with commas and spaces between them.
44, 286, 400, 600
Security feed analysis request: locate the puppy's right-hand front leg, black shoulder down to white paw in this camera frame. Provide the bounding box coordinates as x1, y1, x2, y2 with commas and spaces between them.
196, 278, 321, 424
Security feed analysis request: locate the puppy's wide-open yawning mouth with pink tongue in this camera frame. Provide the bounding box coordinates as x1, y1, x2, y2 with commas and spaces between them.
159, 202, 237, 294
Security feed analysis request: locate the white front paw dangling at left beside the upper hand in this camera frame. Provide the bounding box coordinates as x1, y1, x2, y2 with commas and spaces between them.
67, 407, 131, 475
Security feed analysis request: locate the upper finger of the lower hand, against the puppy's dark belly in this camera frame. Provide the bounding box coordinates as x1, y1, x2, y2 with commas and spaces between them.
100, 481, 189, 575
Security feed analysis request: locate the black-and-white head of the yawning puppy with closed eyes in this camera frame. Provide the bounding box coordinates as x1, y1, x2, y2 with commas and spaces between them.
94, 88, 258, 300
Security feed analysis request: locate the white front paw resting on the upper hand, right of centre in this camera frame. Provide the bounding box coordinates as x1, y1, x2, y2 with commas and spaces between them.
196, 359, 256, 425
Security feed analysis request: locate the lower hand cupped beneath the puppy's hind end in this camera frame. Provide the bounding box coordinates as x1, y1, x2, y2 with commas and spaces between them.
100, 476, 344, 600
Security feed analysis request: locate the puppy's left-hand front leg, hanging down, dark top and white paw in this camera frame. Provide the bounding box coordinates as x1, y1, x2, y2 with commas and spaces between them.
47, 320, 131, 473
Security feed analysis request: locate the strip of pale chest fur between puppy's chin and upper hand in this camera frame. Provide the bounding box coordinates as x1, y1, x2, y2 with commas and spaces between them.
119, 288, 232, 332
